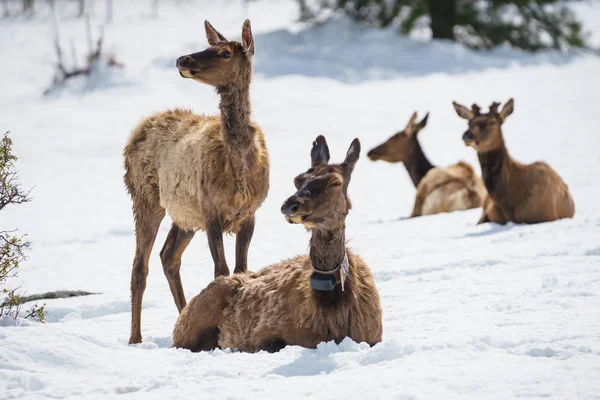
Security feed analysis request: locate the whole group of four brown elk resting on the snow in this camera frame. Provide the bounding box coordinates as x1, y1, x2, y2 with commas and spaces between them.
123, 20, 574, 352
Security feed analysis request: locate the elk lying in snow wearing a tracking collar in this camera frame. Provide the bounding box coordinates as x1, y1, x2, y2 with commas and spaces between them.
173, 136, 382, 352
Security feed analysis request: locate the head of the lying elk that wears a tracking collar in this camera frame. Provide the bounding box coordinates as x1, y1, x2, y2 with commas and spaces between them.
281, 136, 360, 229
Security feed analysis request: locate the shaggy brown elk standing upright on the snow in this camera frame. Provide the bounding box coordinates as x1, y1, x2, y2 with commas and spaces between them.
123, 20, 269, 343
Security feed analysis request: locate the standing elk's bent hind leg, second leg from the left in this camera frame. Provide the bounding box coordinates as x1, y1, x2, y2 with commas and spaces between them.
160, 224, 195, 312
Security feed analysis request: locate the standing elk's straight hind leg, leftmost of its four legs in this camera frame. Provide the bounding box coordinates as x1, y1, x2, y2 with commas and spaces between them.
129, 203, 165, 344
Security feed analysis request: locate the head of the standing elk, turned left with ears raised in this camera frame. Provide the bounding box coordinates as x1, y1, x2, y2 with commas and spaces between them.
177, 20, 254, 87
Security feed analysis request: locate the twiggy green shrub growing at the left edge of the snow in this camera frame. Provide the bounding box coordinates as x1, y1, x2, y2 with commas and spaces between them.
0, 132, 46, 322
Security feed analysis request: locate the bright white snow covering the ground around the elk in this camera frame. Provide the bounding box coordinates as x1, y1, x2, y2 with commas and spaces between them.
0, 0, 600, 399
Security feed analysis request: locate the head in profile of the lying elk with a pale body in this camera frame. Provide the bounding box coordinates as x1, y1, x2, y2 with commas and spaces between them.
367, 112, 429, 163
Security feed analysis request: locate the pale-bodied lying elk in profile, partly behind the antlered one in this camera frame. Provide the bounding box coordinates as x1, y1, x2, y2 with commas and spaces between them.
367, 112, 485, 218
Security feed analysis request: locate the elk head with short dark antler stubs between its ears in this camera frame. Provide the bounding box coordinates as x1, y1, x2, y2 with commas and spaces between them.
452, 99, 514, 153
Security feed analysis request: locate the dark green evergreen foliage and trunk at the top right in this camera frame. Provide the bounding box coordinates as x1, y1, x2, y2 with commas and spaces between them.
299, 0, 585, 51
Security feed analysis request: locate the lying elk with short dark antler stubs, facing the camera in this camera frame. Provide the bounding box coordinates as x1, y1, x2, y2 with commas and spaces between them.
452, 99, 575, 224
